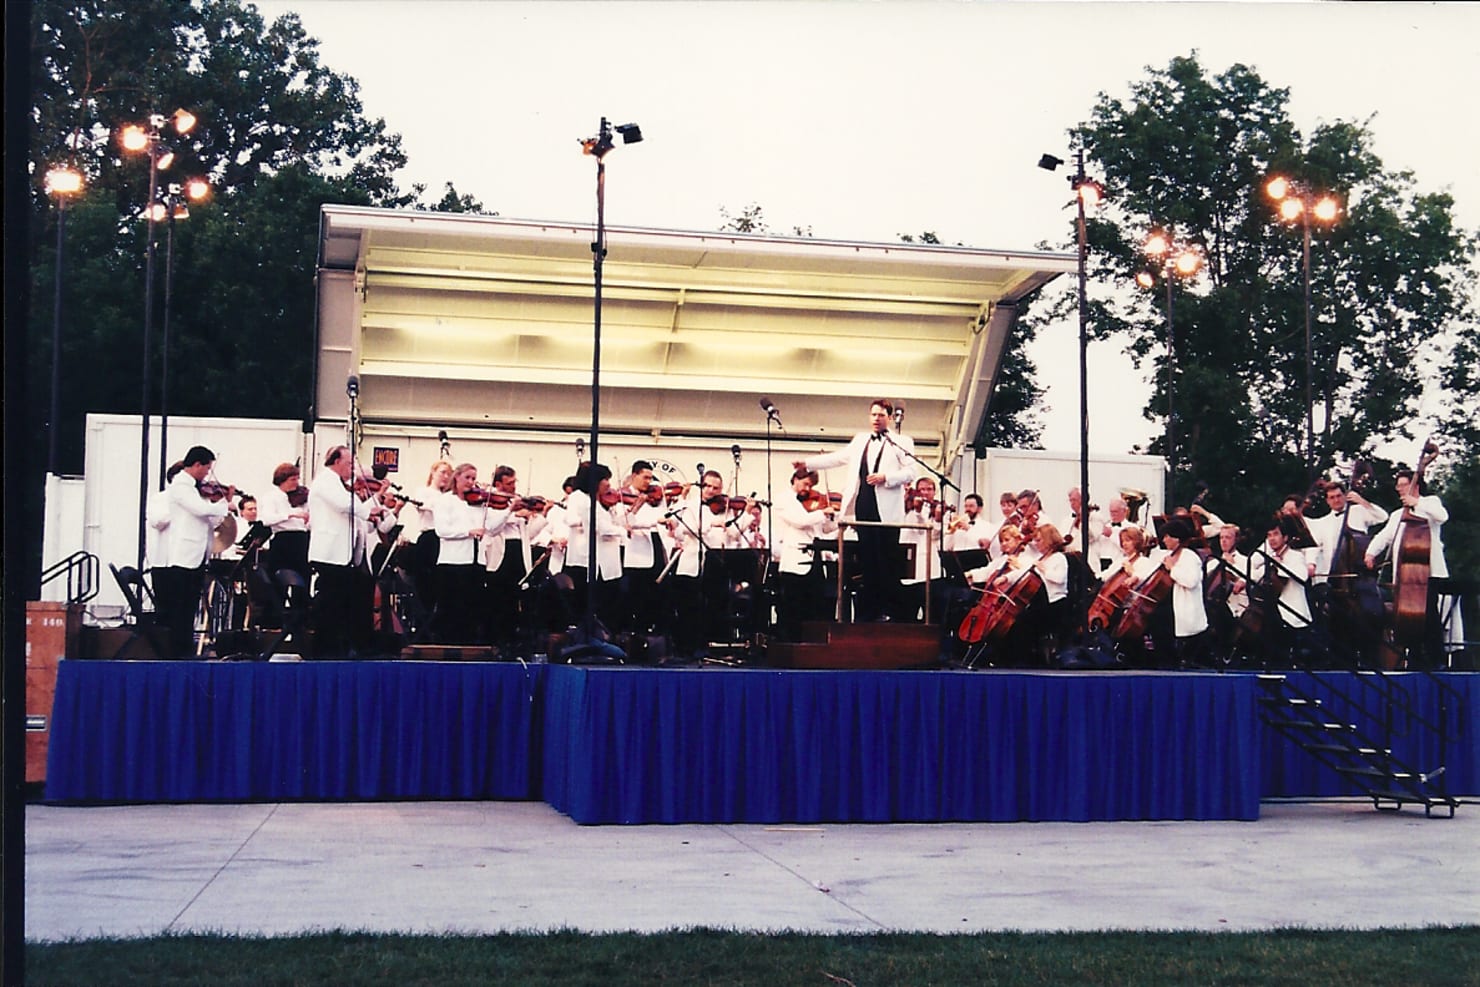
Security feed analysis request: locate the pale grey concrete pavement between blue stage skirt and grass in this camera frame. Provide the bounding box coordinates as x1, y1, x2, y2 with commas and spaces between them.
25, 802, 1480, 940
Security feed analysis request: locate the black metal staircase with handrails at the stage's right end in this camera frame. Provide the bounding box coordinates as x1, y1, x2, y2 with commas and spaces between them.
1258, 669, 1464, 818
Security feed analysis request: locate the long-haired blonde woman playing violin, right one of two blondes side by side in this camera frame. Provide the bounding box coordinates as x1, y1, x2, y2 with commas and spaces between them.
432, 463, 488, 644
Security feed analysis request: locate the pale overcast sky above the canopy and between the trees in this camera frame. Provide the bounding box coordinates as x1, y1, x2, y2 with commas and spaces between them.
258, 0, 1480, 451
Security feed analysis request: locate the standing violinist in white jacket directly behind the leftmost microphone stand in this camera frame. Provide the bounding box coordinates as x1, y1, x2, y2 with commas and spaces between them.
308, 445, 392, 657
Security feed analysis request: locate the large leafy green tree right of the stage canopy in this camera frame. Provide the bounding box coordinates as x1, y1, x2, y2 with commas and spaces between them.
1074, 55, 1477, 513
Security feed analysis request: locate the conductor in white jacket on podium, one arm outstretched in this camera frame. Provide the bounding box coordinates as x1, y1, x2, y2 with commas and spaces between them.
792, 398, 915, 621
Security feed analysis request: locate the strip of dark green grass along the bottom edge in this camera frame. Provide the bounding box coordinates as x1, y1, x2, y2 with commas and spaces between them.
27, 926, 1480, 987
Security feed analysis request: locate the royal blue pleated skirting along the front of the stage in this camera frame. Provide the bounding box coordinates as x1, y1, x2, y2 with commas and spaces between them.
46, 660, 1480, 823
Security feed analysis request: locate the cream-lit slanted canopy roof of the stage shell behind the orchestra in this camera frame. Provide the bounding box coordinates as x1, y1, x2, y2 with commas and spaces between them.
317, 206, 1074, 451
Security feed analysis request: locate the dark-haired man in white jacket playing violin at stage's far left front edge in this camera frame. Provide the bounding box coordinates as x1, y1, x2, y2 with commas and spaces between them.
154, 445, 237, 658
